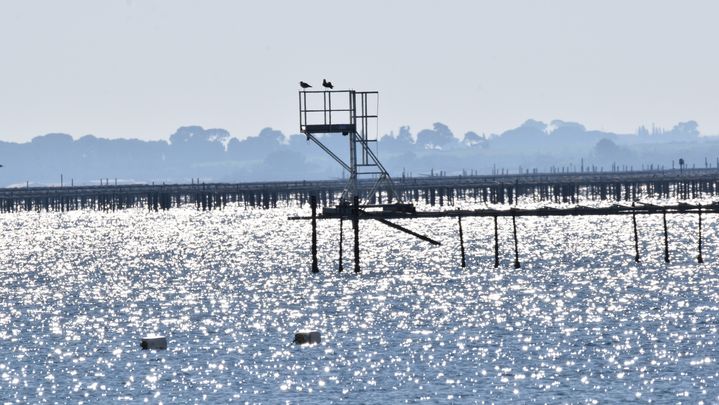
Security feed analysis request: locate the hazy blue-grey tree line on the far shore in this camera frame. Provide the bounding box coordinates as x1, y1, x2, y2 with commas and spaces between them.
0, 120, 719, 187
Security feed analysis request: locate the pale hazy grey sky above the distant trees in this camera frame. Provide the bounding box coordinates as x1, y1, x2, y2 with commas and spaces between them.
0, 0, 719, 141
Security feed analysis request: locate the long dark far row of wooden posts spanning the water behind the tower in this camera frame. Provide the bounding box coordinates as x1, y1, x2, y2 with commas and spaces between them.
0, 169, 719, 212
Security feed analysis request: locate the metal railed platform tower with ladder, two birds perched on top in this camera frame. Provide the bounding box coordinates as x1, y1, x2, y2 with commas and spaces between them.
299, 90, 404, 207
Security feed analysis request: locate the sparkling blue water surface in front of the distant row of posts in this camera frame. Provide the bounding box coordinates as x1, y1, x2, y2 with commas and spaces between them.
0, 200, 719, 403
